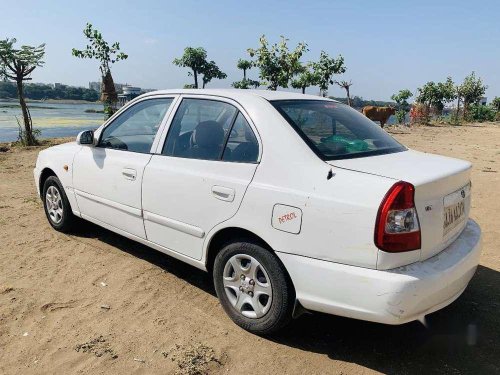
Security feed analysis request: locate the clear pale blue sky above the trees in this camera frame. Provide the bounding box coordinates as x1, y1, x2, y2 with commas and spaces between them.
0, 0, 500, 100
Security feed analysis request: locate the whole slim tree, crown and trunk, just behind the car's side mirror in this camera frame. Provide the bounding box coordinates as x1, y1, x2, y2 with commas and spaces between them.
71, 23, 128, 117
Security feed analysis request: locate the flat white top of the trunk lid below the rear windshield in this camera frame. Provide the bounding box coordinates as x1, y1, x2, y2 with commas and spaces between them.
328, 150, 471, 185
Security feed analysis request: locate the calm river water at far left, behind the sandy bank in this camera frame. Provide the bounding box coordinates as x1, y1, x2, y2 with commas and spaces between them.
0, 100, 104, 142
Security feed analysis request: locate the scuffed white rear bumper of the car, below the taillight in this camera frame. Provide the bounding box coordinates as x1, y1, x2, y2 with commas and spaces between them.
277, 220, 481, 324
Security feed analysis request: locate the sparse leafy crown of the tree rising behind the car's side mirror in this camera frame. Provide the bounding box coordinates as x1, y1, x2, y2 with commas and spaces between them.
71, 23, 128, 77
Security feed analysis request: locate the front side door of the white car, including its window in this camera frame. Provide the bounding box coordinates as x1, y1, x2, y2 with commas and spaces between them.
73, 97, 174, 238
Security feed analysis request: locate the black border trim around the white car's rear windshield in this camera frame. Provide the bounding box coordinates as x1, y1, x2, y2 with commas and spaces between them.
269, 99, 408, 162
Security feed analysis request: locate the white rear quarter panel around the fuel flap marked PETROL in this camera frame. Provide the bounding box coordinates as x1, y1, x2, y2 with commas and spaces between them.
201, 98, 395, 268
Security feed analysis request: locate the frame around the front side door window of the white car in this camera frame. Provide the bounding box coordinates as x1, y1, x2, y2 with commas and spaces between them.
94, 94, 179, 155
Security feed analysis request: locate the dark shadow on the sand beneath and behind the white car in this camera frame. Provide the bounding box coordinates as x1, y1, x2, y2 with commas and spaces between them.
70, 222, 500, 374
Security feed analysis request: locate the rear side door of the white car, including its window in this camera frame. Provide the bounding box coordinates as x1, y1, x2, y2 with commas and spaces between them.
143, 96, 260, 259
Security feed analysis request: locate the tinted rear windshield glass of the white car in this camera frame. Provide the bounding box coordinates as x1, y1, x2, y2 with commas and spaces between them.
271, 100, 406, 160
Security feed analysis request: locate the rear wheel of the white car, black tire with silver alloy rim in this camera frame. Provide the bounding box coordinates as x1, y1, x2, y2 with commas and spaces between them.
213, 240, 295, 335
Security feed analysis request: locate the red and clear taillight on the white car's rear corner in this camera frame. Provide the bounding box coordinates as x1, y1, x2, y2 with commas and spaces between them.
375, 181, 420, 253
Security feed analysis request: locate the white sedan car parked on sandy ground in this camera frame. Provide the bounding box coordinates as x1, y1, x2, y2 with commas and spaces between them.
34, 90, 481, 334
